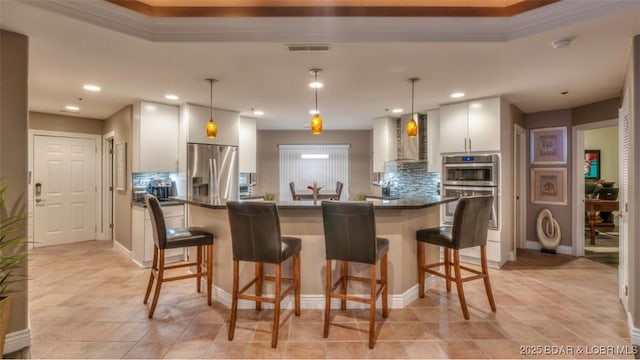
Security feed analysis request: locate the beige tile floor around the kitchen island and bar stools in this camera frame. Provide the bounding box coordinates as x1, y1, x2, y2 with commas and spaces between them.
21, 241, 633, 359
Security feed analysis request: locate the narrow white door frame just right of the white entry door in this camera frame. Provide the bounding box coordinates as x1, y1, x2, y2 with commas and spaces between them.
101, 131, 116, 240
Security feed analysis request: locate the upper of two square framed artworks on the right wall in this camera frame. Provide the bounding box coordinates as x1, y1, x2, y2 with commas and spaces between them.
531, 126, 567, 164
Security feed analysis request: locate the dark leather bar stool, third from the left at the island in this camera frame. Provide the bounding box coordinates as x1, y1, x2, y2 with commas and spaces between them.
322, 201, 389, 349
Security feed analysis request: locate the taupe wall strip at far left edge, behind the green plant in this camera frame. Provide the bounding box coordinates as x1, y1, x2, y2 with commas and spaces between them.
0, 30, 29, 344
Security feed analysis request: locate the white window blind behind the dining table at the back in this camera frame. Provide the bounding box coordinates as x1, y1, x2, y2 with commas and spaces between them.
279, 145, 350, 201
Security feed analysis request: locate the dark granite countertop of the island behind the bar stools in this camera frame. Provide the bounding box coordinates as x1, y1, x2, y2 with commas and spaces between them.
171, 196, 458, 209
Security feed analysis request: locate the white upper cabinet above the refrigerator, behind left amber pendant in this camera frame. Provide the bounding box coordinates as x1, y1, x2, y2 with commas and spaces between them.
182, 104, 240, 146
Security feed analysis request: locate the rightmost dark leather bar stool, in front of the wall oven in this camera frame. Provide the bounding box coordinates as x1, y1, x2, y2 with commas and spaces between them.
416, 196, 496, 320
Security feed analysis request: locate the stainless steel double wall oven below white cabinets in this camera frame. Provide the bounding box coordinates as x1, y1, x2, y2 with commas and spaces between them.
441, 154, 500, 229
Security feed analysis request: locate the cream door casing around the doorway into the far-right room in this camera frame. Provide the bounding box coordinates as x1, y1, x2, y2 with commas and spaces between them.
571, 118, 618, 256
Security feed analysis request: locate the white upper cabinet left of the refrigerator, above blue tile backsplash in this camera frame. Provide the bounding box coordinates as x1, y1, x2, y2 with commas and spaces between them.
132, 101, 180, 172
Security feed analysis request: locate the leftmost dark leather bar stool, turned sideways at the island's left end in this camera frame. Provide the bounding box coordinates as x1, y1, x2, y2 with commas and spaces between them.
144, 195, 213, 318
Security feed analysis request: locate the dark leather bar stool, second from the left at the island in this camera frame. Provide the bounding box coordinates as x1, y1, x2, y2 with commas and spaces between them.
227, 201, 302, 348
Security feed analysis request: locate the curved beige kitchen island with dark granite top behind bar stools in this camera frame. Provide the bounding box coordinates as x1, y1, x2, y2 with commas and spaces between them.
172, 196, 457, 308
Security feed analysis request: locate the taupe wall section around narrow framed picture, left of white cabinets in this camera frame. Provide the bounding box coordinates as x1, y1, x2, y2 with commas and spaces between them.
104, 105, 133, 250
